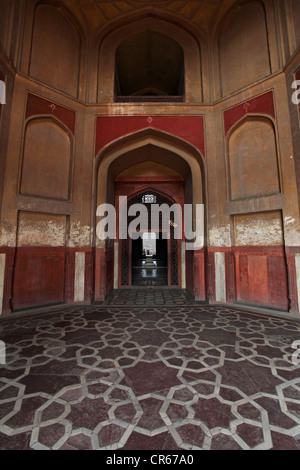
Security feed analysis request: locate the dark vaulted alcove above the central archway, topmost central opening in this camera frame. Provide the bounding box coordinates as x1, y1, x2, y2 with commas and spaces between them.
95, 15, 203, 102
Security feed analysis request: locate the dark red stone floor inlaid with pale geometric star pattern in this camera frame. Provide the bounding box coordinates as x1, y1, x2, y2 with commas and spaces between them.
0, 290, 300, 451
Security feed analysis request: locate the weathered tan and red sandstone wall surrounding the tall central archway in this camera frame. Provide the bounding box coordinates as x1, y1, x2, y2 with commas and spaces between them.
0, 0, 300, 313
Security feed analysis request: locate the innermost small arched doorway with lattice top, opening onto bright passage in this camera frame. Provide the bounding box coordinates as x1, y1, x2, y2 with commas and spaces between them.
119, 187, 183, 287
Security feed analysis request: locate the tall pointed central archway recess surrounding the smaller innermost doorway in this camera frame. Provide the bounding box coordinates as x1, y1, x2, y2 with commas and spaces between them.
95, 130, 206, 301
